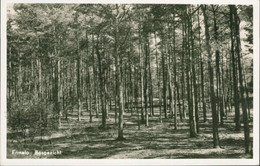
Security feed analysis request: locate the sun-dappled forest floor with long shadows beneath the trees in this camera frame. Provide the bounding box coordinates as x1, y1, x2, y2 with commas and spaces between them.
7, 105, 253, 159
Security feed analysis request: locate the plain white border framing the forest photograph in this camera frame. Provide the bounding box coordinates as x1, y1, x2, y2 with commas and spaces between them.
0, 0, 259, 165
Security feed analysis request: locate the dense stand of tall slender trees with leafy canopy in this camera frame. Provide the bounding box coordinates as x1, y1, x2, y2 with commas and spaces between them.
7, 4, 253, 153
